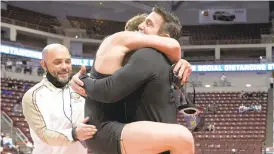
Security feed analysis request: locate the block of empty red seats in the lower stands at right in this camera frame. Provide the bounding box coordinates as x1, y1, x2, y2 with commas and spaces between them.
177, 92, 267, 154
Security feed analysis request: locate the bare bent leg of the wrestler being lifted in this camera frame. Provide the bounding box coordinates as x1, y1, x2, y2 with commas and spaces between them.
121, 121, 194, 154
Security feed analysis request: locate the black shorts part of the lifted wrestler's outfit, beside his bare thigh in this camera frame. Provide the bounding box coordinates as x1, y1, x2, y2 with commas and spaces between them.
86, 122, 125, 154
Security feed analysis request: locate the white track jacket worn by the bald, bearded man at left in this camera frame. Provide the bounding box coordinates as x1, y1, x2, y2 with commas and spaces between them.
22, 78, 87, 154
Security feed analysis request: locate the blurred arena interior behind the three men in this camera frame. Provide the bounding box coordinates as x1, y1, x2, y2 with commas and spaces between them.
0, 1, 274, 154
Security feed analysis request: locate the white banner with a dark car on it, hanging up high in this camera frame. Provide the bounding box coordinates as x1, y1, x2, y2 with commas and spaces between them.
199, 9, 246, 24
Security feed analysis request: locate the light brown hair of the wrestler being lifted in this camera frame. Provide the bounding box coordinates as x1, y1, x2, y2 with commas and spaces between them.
125, 13, 147, 31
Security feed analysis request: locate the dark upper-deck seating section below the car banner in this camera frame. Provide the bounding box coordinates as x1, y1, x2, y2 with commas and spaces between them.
183, 24, 271, 45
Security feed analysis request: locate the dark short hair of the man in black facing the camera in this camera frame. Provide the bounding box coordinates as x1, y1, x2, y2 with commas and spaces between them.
152, 6, 182, 40
